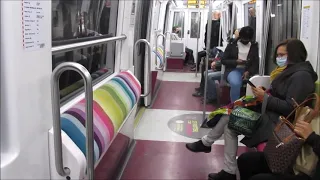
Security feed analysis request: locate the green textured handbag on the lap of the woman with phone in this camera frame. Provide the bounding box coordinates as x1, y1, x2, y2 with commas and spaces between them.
228, 107, 261, 137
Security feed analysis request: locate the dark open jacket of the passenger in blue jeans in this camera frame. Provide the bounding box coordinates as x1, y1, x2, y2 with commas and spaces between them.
221, 40, 259, 79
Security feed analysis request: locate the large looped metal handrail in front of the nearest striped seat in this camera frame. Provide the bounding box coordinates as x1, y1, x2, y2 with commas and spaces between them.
51, 62, 94, 180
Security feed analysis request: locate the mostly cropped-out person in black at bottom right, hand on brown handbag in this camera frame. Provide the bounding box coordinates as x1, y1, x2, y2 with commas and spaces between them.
238, 121, 320, 180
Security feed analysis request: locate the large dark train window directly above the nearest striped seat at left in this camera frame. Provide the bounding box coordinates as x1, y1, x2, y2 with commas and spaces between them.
52, 0, 119, 102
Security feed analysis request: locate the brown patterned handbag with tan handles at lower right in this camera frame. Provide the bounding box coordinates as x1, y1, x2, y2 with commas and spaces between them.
264, 94, 319, 174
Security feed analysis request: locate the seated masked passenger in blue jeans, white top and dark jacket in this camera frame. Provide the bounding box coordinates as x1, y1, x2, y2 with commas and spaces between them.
221, 26, 259, 102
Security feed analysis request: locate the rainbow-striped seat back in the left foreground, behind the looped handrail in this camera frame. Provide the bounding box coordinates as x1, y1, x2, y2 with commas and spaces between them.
61, 71, 141, 162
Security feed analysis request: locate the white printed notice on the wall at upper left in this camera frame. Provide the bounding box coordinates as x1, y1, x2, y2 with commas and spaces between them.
22, 0, 45, 51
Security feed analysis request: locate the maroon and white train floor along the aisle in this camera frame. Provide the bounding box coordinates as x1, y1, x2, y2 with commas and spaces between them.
121, 71, 246, 179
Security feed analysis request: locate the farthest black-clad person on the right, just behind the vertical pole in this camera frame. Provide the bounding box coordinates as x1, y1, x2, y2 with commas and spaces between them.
191, 11, 222, 71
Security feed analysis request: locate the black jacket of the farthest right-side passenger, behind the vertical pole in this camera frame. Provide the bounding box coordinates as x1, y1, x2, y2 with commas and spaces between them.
204, 20, 222, 49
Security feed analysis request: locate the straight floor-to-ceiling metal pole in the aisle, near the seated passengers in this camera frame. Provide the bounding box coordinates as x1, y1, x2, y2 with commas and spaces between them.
202, 0, 212, 125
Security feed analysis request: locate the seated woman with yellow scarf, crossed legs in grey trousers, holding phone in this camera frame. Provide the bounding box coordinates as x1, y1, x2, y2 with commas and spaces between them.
186, 38, 318, 180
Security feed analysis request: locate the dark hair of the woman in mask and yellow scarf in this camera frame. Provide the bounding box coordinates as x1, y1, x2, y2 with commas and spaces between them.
273, 39, 308, 64
